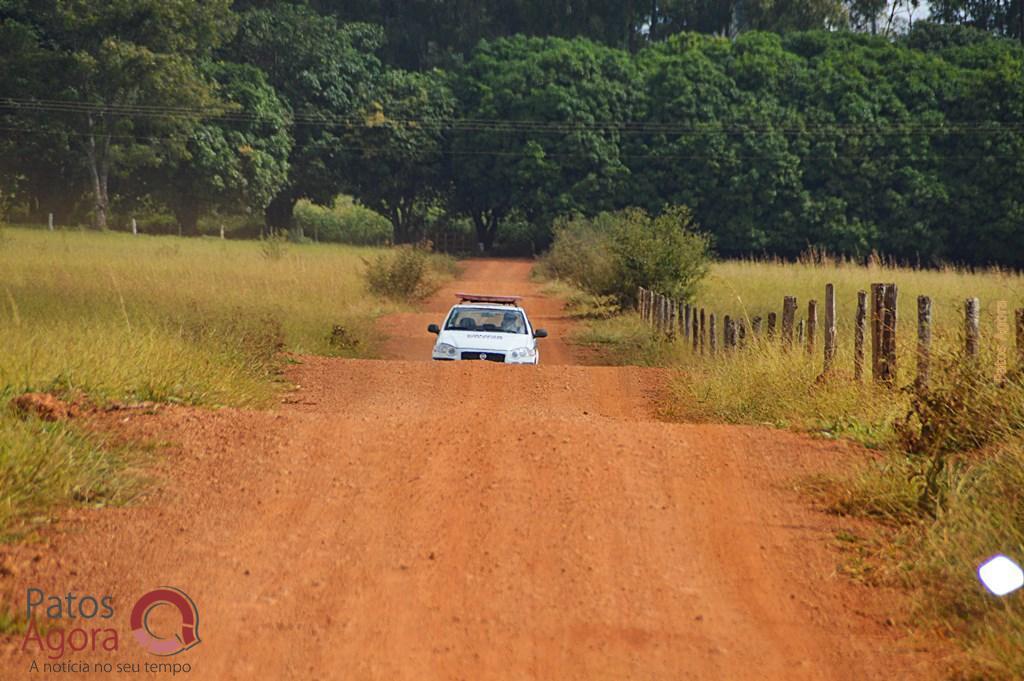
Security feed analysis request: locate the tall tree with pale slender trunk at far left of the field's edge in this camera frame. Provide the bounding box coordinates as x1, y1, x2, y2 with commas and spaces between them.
0, 0, 233, 228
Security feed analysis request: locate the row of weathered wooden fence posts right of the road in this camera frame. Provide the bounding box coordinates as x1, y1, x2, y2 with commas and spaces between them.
637, 283, 1024, 387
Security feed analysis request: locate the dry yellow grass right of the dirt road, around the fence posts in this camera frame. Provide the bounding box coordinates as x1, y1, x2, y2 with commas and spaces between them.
553, 262, 1024, 680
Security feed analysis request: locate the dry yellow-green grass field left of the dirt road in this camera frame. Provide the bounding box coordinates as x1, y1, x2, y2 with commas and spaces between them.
0, 227, 425, 531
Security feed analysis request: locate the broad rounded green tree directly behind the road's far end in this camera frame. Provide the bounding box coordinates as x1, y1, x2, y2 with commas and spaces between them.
449, 37, 639, 248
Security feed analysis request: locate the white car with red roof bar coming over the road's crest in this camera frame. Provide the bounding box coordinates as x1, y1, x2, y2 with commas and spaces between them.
427, 293, 548, 365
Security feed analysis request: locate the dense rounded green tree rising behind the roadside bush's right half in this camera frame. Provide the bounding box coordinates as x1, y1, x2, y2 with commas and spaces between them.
629, 33, 806, 255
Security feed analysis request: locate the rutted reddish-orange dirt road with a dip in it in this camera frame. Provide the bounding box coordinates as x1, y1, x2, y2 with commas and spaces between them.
0, 261, 929, 681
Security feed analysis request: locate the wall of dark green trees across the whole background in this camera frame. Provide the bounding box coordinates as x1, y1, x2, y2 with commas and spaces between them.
0, 0, 1024, 266
